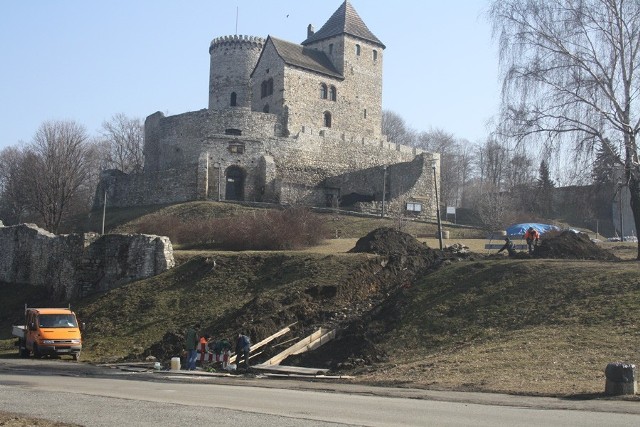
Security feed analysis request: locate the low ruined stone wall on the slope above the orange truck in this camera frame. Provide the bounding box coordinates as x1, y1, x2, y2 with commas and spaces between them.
0, 224, 175, 300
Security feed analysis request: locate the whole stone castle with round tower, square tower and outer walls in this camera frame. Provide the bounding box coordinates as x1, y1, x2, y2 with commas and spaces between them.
94, 0, 440, 218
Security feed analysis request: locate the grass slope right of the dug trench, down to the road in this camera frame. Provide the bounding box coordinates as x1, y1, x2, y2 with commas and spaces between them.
363, 260, 640, 395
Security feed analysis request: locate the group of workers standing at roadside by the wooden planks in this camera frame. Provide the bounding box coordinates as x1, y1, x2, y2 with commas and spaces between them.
184, 323, 251, 371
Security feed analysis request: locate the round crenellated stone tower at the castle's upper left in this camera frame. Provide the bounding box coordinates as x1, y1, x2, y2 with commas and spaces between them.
209, 35, 264, 110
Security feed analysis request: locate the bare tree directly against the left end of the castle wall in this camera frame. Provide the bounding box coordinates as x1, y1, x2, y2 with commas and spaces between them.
101, 113, 144, 173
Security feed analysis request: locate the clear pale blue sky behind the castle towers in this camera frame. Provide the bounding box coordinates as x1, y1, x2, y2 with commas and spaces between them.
0, 0, 500, 149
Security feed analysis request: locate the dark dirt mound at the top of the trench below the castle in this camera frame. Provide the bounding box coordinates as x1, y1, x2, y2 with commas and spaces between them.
349, 227, 432, 256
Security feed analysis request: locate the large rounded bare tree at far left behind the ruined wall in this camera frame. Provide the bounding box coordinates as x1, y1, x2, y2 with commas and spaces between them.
21, 121, 89, 233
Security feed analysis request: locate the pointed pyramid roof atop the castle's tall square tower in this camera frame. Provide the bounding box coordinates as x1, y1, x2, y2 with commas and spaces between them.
302, 0, 385, 48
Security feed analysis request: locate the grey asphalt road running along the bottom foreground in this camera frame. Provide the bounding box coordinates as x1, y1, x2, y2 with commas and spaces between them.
0, 359, 640, 426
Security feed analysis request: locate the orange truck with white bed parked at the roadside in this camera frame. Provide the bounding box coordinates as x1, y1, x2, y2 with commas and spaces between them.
12, 306, 82, 360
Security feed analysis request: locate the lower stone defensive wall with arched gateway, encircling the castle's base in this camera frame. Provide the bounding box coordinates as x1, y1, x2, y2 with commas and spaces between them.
94, 108, 439, 217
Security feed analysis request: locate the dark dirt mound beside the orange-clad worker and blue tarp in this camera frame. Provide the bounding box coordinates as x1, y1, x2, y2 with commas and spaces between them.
532, 231, 619, 261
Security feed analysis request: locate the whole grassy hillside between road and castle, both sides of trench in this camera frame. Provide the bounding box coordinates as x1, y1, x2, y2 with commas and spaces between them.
0, 205, 640, 395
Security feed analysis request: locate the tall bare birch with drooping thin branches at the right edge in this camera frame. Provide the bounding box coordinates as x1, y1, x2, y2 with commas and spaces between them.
489, 0, 640, 259
